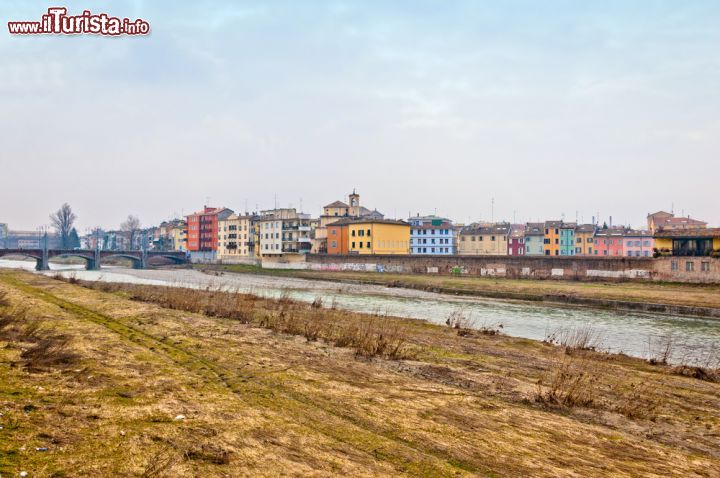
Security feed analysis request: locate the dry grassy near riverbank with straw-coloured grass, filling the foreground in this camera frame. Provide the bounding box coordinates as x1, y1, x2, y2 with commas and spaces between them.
0, 271, 720, 476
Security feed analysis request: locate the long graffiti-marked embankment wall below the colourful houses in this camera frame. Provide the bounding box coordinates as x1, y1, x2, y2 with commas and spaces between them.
263, 254, 720, 283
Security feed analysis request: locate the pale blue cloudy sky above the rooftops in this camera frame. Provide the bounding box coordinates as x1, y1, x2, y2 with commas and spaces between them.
0, 0, 720, 233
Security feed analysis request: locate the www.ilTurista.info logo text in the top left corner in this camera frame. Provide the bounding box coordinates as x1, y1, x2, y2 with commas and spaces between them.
8, 7, 150, 36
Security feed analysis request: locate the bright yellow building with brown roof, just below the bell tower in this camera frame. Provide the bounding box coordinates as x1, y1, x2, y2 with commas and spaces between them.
333, 218, 410, 254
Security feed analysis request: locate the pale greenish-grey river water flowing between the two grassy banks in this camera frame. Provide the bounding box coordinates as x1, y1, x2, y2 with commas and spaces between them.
0, 260, 720, 367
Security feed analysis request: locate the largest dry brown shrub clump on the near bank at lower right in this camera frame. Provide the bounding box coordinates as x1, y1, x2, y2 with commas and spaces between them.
535, 357, 600, 407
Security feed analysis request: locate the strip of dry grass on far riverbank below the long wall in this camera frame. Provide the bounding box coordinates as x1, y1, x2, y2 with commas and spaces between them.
197, 264, 720, 318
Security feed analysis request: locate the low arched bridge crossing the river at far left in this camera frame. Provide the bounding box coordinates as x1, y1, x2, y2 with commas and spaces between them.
0, 249, 188, 271
